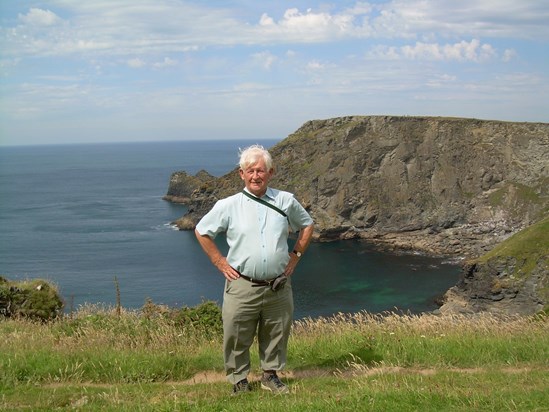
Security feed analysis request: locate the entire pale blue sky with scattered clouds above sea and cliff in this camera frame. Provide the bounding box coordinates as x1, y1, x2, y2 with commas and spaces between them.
0, 0, 549, 145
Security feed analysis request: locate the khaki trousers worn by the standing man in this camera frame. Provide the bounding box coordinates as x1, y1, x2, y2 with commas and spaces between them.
223, 278, 294, 384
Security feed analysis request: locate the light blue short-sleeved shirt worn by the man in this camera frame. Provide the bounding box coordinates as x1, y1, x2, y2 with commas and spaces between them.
196, 188, 313, 280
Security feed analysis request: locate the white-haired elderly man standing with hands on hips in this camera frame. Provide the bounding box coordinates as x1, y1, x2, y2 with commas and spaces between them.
195, 145, 313, 394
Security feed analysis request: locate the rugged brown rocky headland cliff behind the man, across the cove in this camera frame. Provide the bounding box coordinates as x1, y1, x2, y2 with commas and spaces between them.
170, 116, 549, 316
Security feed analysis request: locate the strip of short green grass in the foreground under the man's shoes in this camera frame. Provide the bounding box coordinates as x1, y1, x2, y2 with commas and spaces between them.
0, 370, 549, 412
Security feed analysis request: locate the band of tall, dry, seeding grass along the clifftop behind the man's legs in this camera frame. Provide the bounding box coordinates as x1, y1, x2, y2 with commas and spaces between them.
0, 306, 549, 382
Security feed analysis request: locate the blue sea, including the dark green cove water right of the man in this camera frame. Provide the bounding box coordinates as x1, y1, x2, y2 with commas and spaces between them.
0, 139, 460, 319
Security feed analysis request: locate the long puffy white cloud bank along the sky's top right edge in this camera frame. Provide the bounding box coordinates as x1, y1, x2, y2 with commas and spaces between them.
251, 0, 549, 43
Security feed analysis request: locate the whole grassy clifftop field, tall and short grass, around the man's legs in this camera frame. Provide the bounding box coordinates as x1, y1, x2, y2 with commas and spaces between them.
0, 304, 549, 411
